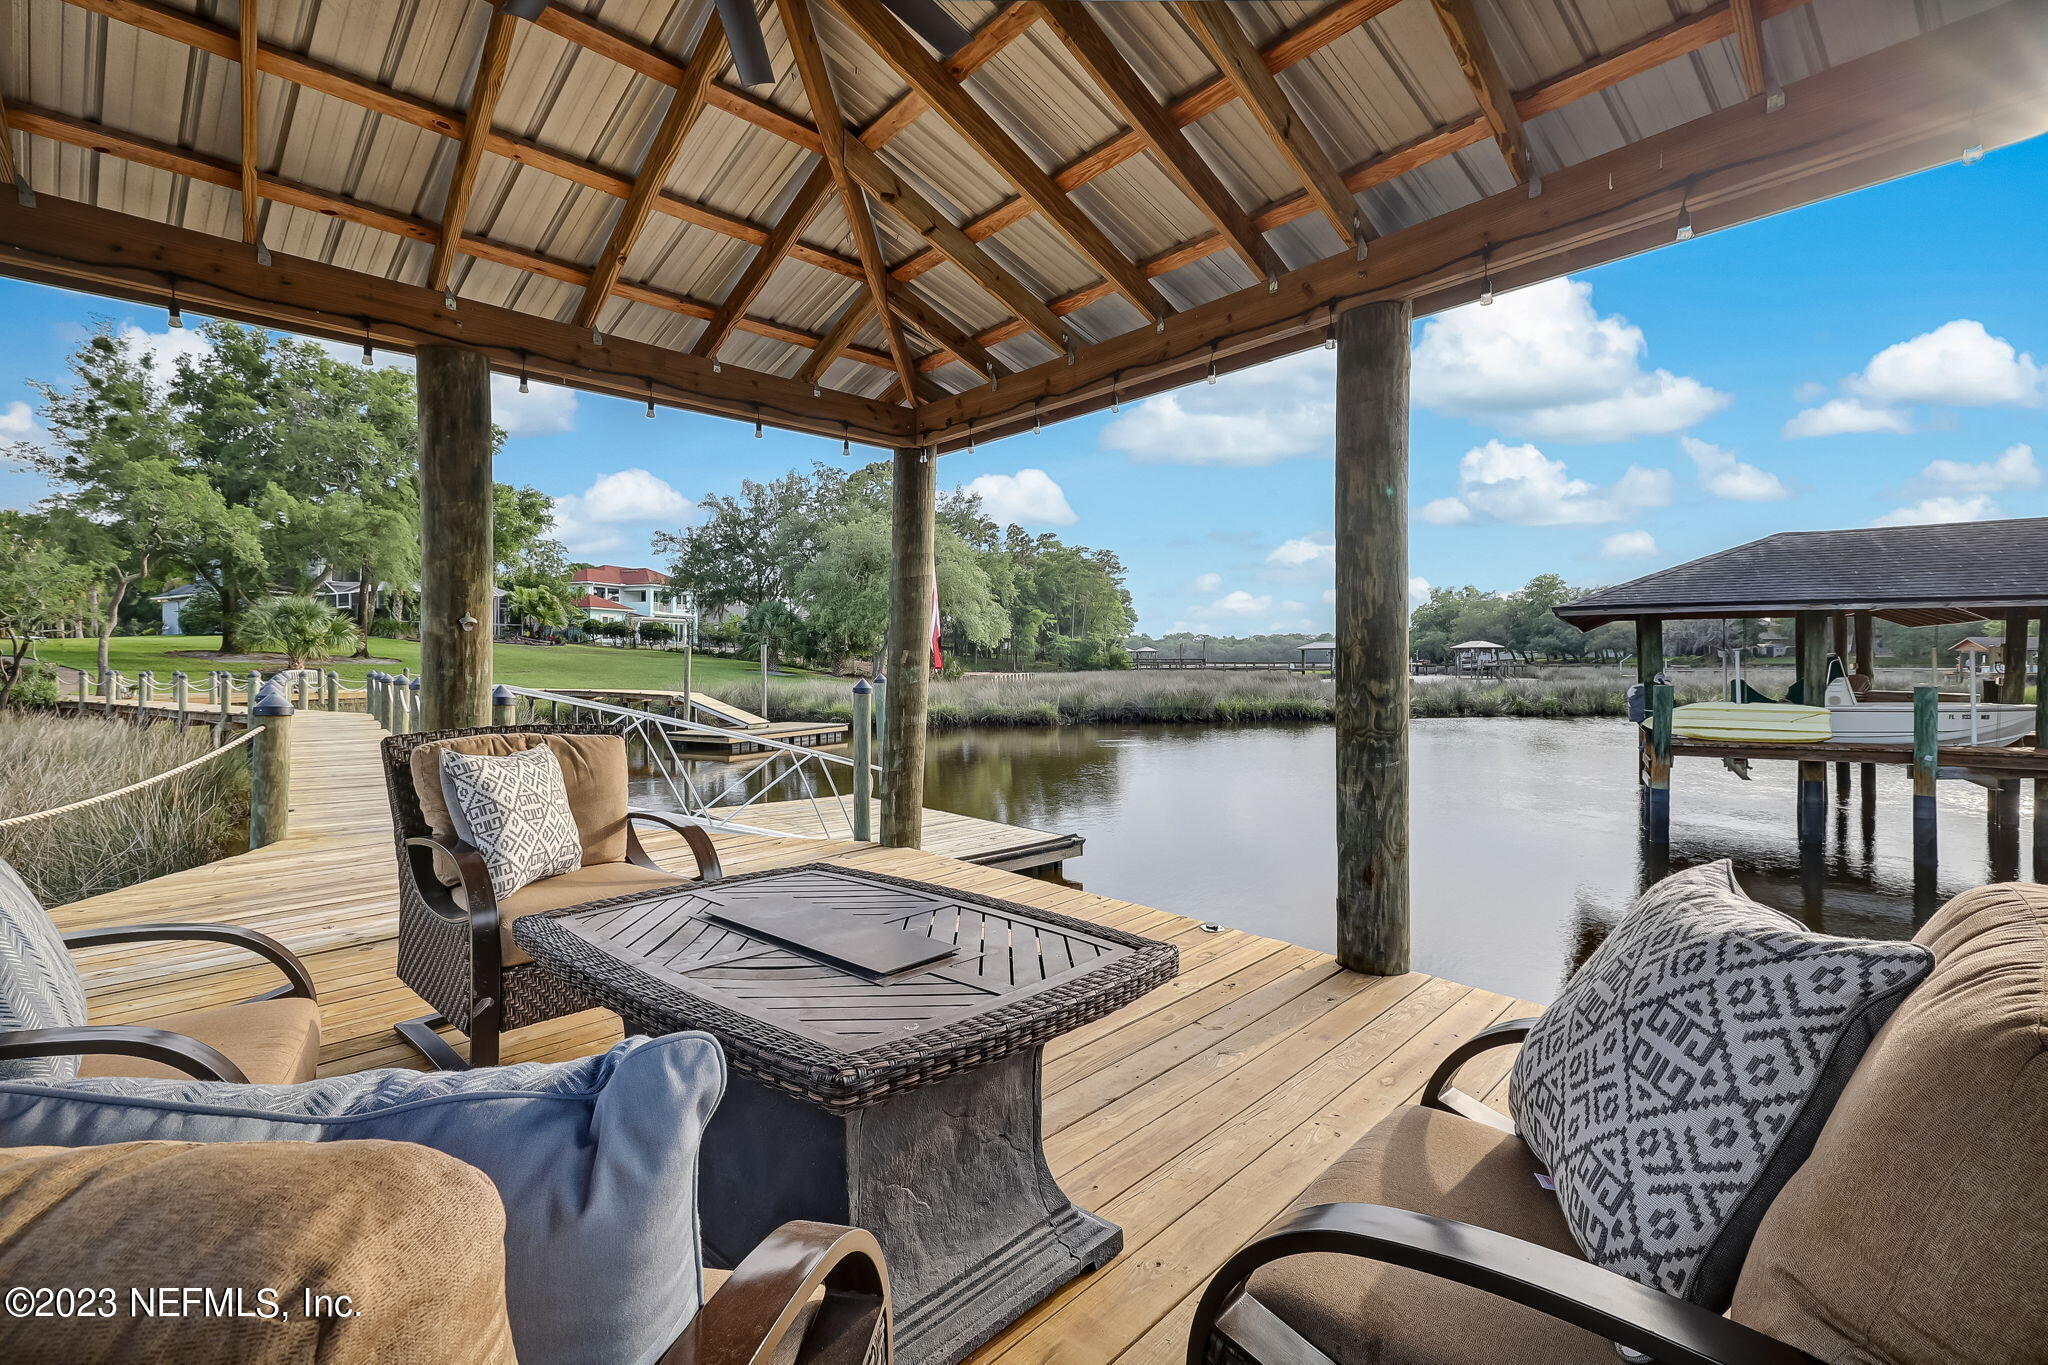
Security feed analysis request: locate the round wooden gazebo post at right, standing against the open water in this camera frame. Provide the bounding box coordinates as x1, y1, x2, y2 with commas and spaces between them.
1333, 299, 1413, 976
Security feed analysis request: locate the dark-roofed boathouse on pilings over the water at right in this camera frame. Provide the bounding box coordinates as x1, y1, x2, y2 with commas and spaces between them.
1556, 518, 2048, 916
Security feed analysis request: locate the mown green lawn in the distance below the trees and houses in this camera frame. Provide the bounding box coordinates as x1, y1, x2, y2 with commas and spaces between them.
37, 634, 806, 690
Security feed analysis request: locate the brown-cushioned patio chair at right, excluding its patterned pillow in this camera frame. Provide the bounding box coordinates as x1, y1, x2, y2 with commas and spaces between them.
1188, 884, 2048, 1365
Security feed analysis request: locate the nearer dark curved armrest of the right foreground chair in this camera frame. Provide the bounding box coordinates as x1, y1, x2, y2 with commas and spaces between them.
1188, 1203, 1812, 1365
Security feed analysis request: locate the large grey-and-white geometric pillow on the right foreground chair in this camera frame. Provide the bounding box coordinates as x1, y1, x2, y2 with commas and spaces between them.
1509, 862, 1933, 1312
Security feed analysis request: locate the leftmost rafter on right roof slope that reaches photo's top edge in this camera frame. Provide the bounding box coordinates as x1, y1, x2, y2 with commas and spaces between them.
831, 0, 1171, 317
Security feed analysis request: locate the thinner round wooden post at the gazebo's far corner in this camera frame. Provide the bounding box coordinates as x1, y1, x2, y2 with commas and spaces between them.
883, 446, 938, 849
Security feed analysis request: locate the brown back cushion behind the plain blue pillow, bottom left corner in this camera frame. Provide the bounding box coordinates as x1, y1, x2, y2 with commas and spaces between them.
0, 1142, 512, 1365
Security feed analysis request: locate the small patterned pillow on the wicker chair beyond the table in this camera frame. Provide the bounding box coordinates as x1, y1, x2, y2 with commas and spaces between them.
440, 745, 584, 900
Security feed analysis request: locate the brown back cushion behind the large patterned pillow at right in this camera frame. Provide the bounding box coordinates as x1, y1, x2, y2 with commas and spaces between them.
1731, 884, 2048, 1365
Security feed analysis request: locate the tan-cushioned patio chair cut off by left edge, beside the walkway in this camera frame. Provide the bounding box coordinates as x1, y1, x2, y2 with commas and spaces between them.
0, 862, 319, 1085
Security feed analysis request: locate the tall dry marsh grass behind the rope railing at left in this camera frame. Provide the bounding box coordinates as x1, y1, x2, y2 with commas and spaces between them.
0, 712, 250, 919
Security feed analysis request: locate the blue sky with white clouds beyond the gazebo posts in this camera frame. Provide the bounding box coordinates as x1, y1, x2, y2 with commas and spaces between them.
0, 139, 2048, 634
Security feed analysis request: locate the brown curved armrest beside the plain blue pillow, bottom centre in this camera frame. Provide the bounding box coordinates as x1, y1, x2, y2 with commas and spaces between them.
659, 1222, 893, 1365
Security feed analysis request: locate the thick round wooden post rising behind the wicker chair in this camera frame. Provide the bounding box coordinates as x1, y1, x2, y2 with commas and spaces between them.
414, 346, 496, 731
